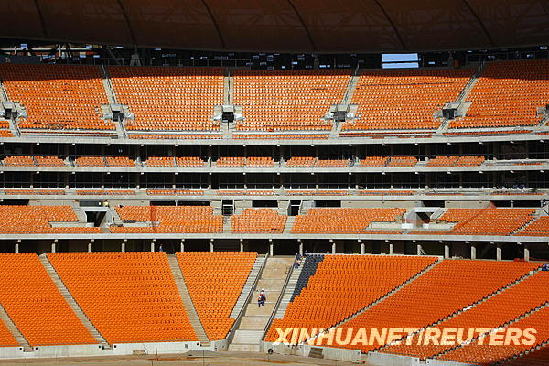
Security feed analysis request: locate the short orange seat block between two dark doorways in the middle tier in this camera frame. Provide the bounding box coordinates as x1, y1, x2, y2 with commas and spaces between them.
231, 208, 287, 233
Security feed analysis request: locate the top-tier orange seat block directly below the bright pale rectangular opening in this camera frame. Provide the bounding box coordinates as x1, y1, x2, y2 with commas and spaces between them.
343, 69, 474, 131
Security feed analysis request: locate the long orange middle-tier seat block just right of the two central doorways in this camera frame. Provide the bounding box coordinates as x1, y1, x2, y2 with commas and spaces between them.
292, 208, 406, 233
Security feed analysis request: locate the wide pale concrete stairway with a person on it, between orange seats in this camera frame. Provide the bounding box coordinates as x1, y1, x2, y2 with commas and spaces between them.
229, 257, 294, 352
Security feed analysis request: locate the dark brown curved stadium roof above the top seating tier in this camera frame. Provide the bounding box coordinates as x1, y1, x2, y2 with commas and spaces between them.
4, 0, 549, 53
